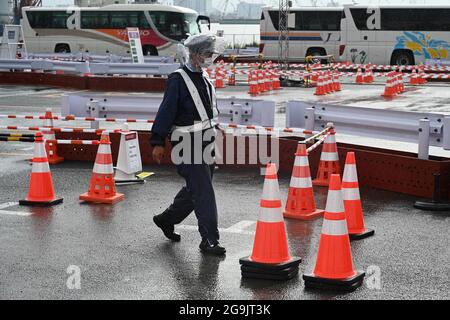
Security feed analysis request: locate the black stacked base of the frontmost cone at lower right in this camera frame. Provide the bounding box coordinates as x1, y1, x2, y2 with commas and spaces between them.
303, 271, 366, 292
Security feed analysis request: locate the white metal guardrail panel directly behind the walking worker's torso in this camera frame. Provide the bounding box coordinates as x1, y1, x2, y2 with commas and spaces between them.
61, 93, 275, 127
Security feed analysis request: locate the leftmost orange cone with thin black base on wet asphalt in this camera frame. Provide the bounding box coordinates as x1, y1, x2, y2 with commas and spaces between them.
19, 132, 63, 206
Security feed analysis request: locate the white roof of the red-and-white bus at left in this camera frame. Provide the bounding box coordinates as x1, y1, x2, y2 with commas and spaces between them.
23, 4, 198, 14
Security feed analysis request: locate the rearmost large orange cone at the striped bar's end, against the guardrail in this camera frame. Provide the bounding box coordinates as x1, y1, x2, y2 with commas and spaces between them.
313, 128, 341, 187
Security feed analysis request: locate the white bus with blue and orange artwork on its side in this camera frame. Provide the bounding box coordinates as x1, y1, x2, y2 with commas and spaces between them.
341, 5, 450, 65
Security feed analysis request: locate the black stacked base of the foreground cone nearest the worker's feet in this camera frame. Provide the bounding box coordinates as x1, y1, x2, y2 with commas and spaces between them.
239, 257, 302, 281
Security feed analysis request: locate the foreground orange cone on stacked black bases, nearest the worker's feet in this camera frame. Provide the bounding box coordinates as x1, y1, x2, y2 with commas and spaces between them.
239, 163, 301, 280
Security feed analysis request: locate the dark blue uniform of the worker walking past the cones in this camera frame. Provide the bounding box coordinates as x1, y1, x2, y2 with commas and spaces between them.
150, 67, 219, 244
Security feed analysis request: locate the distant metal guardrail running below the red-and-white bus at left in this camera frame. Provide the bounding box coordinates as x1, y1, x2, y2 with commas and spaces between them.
0, 59, 179, 75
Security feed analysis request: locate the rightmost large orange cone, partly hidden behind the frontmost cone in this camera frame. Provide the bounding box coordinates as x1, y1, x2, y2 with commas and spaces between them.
342, 152, 375, 240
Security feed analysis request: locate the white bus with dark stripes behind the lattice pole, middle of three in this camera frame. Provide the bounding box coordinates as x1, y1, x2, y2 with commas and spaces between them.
260, 7, 343, 61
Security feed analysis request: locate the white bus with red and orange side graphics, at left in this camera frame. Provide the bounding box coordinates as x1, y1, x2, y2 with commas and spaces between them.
21, 4, 209, 56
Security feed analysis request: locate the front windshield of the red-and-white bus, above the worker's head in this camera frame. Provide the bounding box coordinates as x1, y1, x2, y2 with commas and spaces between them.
149, 11, 200, 41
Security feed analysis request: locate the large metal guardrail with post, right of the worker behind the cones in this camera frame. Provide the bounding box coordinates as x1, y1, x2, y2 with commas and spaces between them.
286, 100, 450, 159
